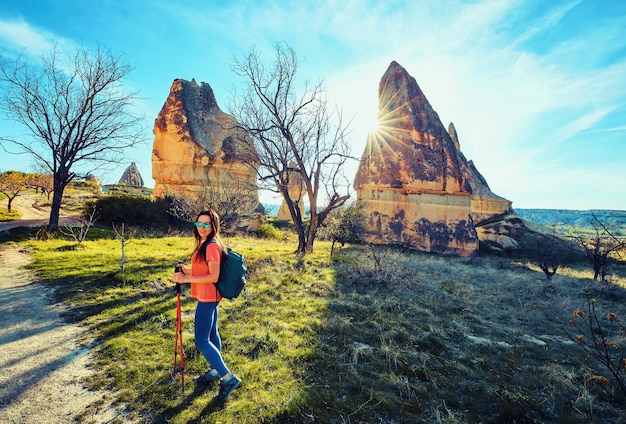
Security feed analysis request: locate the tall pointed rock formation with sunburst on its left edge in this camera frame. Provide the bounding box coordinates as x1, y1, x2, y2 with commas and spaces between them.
354, 62, 511, 255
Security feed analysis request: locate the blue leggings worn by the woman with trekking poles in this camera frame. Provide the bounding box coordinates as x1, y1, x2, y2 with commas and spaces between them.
194, 302, 229, 377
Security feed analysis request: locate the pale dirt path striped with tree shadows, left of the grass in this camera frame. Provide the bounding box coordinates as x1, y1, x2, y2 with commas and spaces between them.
0, 199, 127, 424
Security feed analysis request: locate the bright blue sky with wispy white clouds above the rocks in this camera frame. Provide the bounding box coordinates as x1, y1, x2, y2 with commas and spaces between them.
0, 0, 626, 210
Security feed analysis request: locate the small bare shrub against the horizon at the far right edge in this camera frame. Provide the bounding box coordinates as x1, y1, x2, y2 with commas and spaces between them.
570, 212, 626, 281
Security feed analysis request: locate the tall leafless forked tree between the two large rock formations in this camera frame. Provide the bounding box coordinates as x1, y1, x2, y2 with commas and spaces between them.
231, 43, 350, 253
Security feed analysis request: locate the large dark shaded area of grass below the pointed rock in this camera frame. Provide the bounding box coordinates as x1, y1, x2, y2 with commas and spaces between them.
272, 245, 626, 423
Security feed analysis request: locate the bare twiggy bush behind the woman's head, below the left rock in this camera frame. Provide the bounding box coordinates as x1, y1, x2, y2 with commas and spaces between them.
168, 181, 260, 230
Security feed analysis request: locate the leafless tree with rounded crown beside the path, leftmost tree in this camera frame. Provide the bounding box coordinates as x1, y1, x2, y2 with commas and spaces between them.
0, 47, 142, 229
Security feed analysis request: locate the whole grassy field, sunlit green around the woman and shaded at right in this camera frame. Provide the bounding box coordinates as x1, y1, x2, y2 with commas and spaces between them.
12, 232, 626, 423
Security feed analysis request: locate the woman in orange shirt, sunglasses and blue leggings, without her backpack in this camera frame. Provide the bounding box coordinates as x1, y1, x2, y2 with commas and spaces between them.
172, 209, 241, 402
